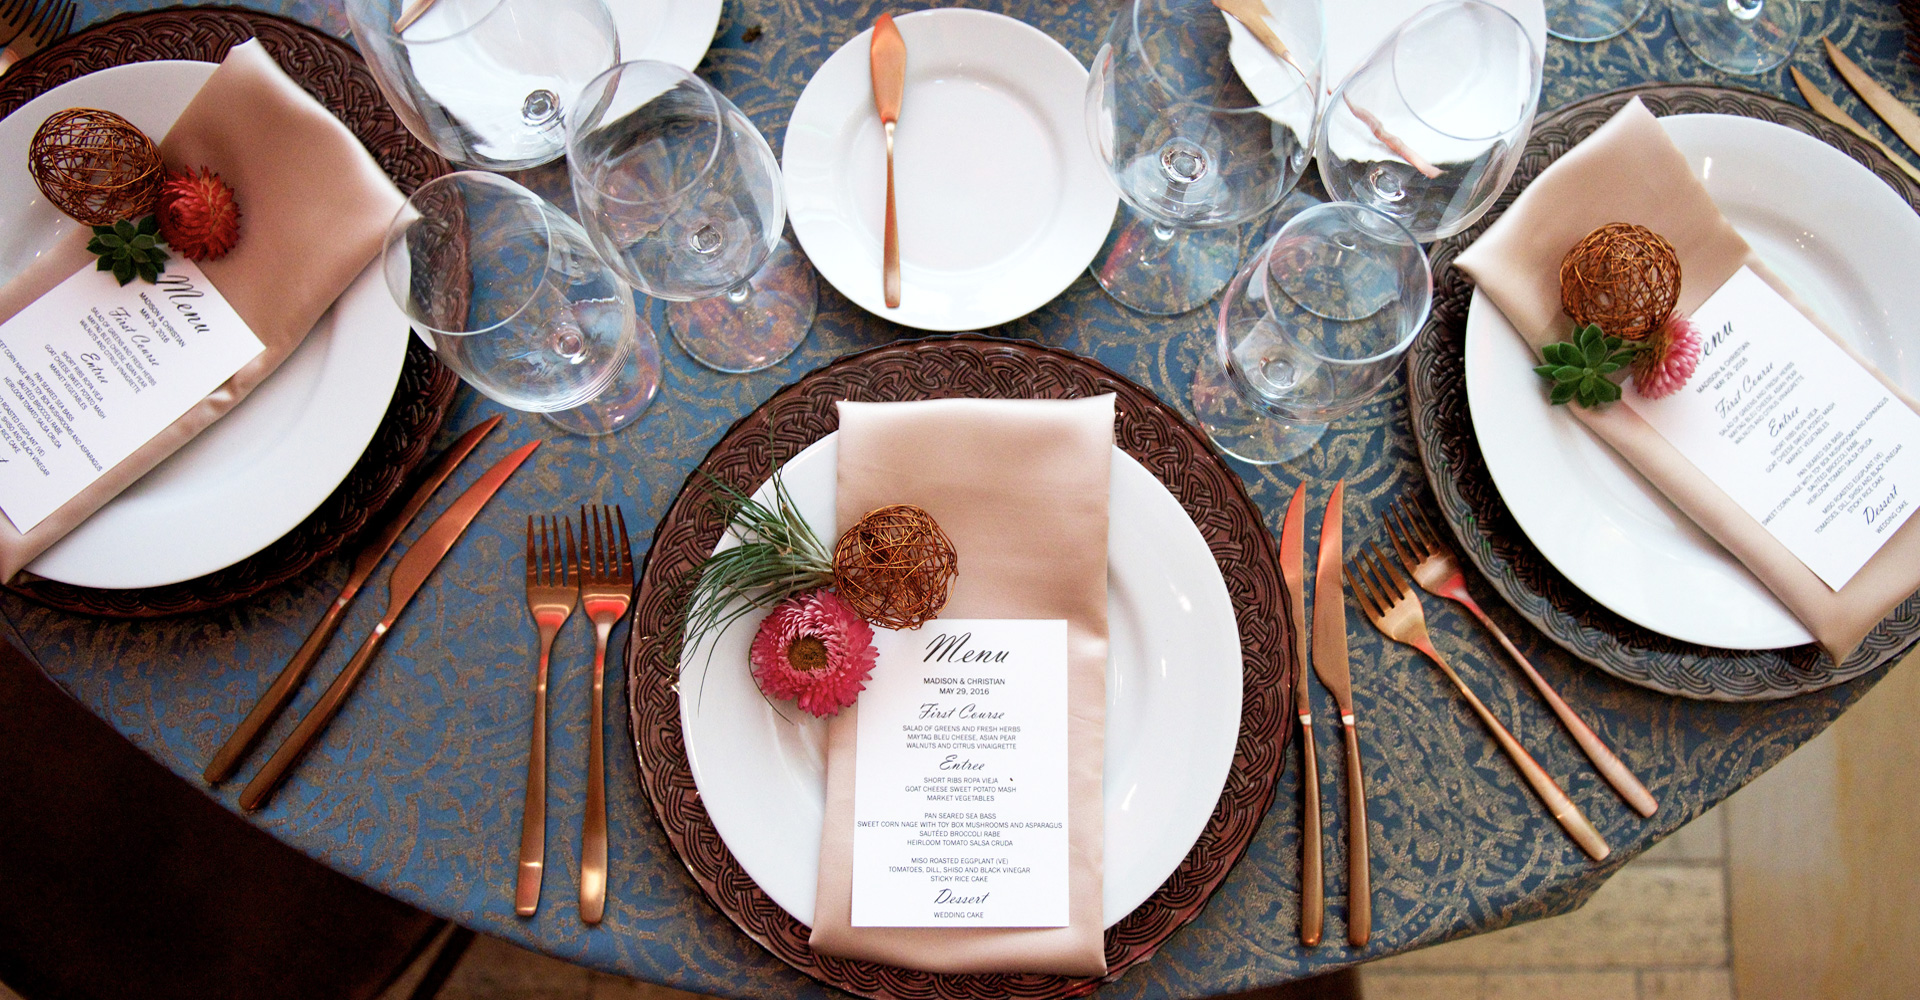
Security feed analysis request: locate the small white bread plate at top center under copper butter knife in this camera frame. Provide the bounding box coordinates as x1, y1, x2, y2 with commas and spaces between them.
781, 8, 1119, 332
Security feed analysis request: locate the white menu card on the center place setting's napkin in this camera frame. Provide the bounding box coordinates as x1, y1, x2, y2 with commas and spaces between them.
852, 618, 1068, 927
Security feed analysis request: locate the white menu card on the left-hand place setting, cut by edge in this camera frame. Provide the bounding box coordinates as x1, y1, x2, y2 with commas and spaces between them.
0, 257, 267, 534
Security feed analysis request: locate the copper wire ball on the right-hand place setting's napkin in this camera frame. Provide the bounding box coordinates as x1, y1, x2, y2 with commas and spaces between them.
1561, 223, 1680, 340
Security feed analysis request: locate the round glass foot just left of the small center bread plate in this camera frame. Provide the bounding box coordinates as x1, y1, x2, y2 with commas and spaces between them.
666, 236, 820, 372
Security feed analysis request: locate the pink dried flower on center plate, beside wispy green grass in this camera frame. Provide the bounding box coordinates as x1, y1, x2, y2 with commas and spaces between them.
751, 589, 879, 716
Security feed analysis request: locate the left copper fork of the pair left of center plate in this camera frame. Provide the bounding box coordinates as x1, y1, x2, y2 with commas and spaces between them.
513, 516, 580, 917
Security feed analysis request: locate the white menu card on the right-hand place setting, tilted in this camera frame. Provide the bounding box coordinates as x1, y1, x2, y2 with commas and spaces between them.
1624, 267, 1920, 591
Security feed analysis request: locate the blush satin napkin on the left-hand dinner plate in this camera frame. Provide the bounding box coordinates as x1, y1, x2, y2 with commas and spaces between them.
0, 38, 405, 580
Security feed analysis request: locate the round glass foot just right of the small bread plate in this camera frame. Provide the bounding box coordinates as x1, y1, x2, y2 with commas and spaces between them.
1089, 203, 1240, 317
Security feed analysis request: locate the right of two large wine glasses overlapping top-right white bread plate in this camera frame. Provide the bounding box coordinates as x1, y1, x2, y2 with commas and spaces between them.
1315, 0, 1540, 244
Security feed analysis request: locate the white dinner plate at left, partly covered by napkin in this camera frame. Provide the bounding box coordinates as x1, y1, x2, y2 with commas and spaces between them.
0, 60, 407, 587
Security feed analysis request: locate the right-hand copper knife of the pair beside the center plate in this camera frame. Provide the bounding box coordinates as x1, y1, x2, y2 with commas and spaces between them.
1313, 480, 1373, 948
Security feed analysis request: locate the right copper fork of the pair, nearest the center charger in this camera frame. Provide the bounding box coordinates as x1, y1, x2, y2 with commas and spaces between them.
580, 505, 634, 923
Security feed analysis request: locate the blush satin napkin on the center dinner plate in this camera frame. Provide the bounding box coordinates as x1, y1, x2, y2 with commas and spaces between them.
812, 395, 1114, 975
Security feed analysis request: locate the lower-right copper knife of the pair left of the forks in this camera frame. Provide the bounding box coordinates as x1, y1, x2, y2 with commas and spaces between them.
240, 441, 540, 812
